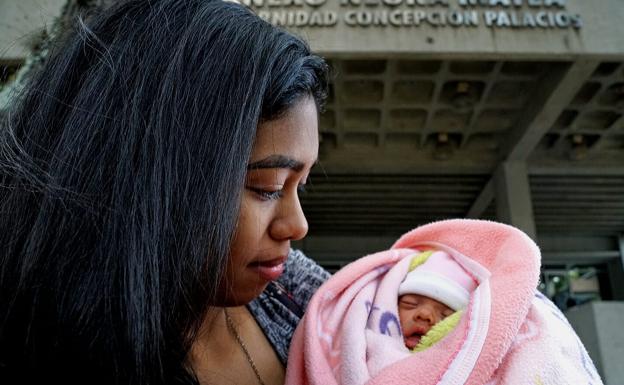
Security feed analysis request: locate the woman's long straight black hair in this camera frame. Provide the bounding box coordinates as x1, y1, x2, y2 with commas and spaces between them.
0, 0, 327, 384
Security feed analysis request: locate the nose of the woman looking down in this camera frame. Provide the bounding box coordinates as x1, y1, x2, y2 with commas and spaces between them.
271, 193, 308, 241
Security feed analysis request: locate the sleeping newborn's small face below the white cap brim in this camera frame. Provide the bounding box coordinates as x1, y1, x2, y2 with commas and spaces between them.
399, 294, 455, 349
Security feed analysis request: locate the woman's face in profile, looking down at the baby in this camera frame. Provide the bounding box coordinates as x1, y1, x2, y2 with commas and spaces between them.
221, 98, 319, 306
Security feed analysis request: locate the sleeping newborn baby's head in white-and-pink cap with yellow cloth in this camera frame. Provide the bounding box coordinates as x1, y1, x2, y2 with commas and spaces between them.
398, 250, 477, 351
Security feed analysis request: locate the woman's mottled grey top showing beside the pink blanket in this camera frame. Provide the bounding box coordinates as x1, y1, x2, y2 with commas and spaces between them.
247, 249, 330, 365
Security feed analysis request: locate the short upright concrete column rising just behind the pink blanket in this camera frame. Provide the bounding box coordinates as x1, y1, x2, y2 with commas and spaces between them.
494, 161, 537, 240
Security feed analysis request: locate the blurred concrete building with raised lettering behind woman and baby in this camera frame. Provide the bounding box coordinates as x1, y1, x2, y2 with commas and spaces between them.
0, 0, 624, 385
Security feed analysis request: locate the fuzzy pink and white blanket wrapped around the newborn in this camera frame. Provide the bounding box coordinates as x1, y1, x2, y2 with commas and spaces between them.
286, 220, 602, 385
